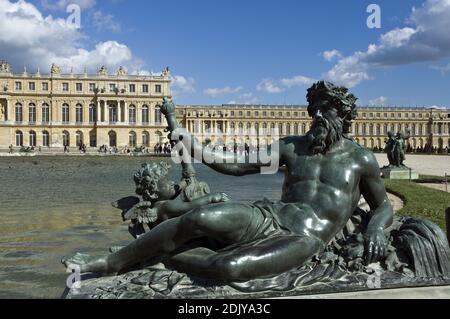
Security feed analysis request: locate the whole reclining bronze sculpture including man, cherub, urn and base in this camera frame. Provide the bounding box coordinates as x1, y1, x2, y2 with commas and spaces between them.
63, 81, 450, 296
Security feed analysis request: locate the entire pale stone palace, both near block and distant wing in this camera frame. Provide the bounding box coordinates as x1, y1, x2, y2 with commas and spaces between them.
0, 62, 450, 149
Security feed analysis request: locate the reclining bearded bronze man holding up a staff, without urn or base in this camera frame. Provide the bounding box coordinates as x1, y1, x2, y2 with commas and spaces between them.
64, 81, 393, 282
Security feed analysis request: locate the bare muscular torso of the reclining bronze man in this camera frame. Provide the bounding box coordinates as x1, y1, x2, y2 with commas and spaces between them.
279, 140, 361, 242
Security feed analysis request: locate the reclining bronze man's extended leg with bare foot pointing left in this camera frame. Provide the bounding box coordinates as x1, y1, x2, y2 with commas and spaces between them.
74, 203, 254, 273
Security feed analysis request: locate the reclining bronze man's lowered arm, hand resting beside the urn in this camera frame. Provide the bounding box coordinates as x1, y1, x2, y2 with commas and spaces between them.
360, 152, 394, 264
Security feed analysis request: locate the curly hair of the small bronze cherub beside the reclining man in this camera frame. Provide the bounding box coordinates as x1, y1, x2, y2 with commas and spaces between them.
134, 162, 171, 202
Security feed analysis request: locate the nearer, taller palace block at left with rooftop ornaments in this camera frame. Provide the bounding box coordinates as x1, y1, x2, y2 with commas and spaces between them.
0, 62, 170, 148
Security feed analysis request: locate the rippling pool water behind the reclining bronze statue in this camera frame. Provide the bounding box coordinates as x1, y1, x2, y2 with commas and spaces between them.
0, 157, 282, 298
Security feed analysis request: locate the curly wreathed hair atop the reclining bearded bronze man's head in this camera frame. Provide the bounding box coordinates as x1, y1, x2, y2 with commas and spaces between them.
306, 81, 358, 133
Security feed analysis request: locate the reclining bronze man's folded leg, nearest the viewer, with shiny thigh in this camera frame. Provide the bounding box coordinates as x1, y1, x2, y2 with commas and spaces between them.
165, 235, 323, 282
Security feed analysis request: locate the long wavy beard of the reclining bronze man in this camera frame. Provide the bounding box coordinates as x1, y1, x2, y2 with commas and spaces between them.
308, 117, 344, 154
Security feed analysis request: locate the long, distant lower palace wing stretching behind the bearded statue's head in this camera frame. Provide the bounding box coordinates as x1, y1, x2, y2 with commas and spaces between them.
177, 105, 450, 149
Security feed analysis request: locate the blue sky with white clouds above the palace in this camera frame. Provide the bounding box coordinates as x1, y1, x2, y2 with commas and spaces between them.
0, 0, 450, 106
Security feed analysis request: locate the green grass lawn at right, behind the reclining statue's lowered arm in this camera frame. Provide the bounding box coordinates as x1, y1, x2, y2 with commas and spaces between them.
385, 180, 450, 230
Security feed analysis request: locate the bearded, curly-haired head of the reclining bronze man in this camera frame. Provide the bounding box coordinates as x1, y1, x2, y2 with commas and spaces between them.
307, 81, 357, 154
